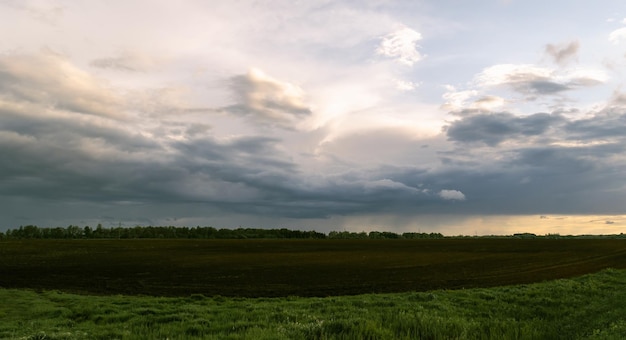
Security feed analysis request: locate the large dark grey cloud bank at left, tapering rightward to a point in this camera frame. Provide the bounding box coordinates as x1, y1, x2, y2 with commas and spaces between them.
0, 83, 443, 222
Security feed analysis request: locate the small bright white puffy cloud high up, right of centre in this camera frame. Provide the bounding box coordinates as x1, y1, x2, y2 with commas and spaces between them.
376, 27, 423, 66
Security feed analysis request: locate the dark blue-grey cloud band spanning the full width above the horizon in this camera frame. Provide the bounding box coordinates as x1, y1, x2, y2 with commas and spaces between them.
0, 97, 626, 230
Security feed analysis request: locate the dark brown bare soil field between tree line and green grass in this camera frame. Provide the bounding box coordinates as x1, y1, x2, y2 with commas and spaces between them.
0, 238, 626, 297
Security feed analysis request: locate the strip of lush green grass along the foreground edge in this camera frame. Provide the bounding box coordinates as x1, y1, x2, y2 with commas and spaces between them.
0, 269, 626, 339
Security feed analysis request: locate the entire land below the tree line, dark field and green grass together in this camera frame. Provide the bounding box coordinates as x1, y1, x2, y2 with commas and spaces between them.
0, 238, 626, 339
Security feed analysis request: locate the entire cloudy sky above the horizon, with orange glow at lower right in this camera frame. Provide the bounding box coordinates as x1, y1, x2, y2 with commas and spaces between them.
0, 0, 626, 235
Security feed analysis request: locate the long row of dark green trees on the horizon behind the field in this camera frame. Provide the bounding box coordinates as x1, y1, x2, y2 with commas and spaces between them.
0, 224, 444, 239
